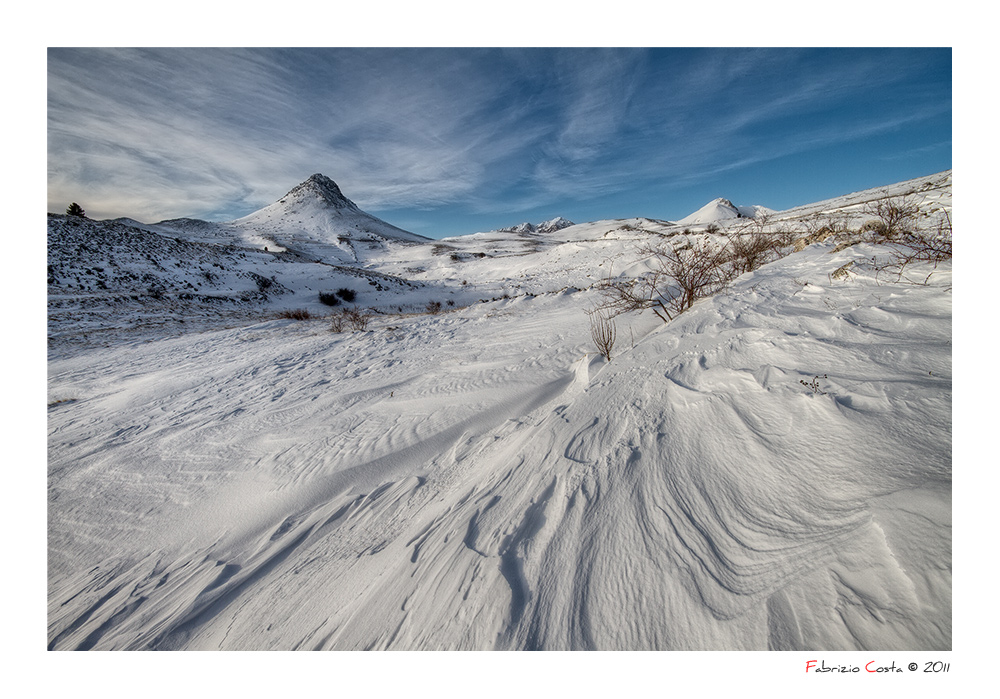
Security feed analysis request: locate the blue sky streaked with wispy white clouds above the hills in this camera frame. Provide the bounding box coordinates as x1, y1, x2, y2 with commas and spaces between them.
48, 48, 952, 237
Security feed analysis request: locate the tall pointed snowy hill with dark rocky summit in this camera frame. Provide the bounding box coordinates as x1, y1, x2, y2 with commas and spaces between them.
226, 174, 429, 261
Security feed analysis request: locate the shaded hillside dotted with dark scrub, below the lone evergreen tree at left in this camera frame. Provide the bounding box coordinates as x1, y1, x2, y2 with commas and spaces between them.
48, 214, 436, 356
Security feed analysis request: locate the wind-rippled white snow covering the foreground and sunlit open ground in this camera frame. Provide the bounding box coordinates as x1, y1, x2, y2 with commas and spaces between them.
48, 172, 951, 650
